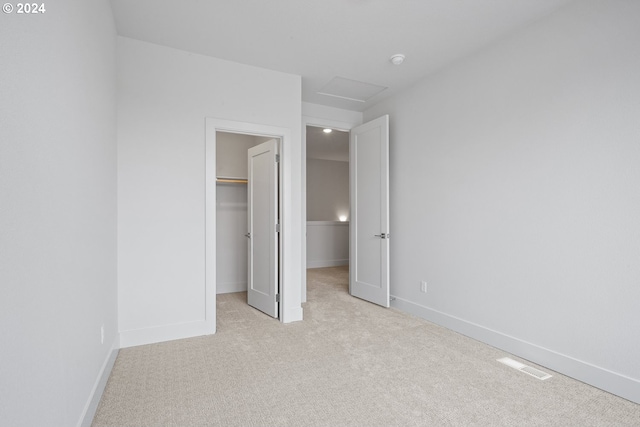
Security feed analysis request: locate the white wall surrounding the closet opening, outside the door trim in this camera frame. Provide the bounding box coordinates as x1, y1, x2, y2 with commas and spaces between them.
118, 38, 302, 346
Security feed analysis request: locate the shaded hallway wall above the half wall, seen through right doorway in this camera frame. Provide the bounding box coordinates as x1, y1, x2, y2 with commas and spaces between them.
307, 159, 349, 221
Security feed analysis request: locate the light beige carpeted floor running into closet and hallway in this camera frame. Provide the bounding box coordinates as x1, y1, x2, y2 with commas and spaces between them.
93, 267, 640, 427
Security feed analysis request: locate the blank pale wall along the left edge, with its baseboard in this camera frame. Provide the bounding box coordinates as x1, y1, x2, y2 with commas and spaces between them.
0, 0, 118, 426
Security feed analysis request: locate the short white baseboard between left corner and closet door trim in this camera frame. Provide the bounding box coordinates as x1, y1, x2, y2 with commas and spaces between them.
120, 320, 215, 348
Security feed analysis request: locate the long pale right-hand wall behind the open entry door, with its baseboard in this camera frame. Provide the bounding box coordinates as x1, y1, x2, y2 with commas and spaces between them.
365, 1, 640, 402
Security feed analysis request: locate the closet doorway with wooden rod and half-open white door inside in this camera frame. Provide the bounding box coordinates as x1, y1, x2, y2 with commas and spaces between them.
216, 131, 280, 318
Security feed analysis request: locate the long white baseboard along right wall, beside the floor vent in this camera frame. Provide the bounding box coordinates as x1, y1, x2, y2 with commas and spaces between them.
391, 296, 640, 403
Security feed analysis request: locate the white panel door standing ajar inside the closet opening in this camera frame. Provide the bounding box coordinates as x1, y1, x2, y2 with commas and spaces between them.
247, 139, 280, 317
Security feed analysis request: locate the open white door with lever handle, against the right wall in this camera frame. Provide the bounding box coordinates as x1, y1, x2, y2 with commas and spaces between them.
349, 115, 389, 307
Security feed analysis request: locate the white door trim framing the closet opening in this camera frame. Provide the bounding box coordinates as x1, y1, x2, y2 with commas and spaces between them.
204, 117, 302, 334
